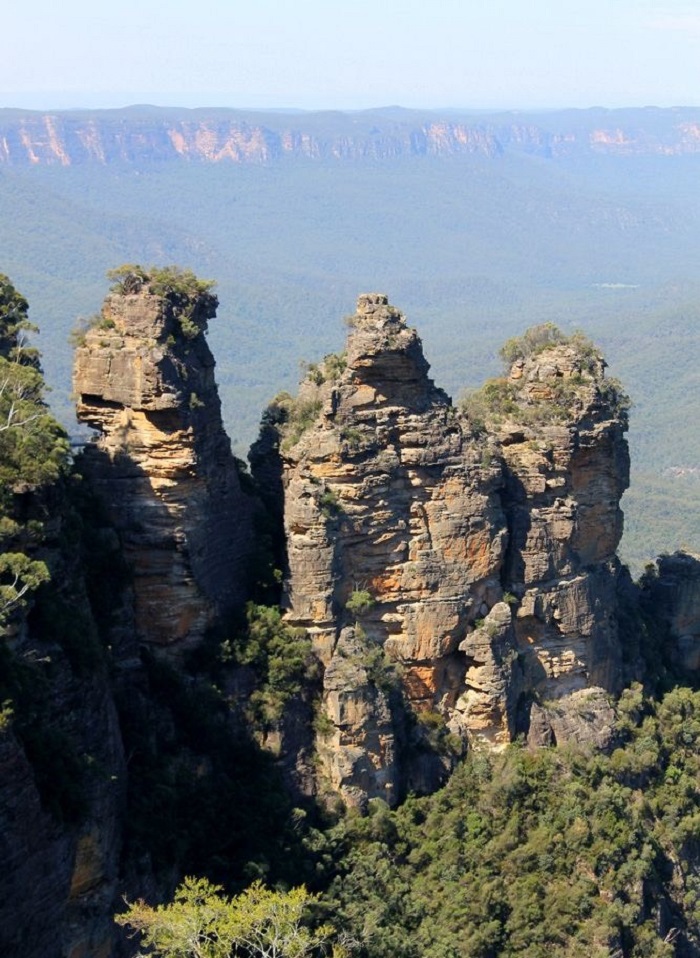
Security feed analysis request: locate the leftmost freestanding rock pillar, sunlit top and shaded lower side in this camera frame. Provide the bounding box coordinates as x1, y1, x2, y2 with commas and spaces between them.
73, 277, 251, 651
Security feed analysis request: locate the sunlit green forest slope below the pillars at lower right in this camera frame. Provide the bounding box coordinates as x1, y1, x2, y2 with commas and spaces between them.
328, 688, 700, 958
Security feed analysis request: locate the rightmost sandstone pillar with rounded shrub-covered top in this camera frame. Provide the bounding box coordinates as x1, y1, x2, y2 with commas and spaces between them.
467, 338, 629, 741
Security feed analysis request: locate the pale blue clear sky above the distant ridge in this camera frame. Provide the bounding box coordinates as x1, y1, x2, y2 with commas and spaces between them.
0, 0, 700, 110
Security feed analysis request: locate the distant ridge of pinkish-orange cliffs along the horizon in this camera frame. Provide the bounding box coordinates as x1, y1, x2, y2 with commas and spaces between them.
0, 107, 700, 166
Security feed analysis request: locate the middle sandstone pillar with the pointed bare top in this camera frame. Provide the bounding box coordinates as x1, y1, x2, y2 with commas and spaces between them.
254, 294, 508, 802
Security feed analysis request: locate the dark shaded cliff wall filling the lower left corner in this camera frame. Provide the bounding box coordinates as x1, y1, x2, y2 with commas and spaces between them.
0, 496, 126, 958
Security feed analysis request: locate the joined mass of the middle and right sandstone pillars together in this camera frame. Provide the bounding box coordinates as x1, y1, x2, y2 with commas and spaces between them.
252, 294, 628, 805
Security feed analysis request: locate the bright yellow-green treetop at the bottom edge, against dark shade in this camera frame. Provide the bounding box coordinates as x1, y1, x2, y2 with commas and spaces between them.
115, 878, 340, 958
